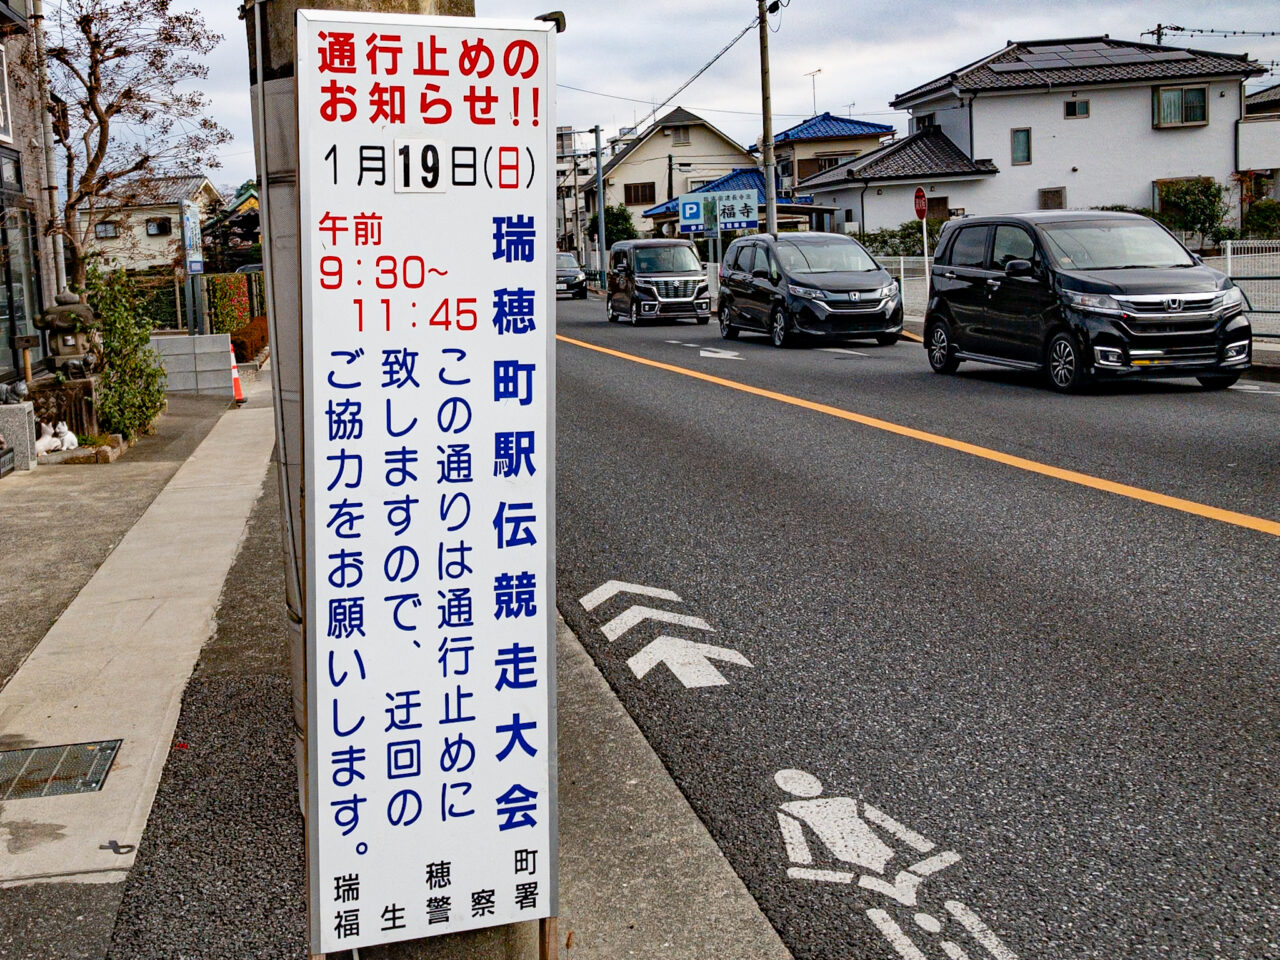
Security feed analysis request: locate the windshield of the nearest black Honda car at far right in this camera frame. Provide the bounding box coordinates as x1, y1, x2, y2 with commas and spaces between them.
1039, 220, 1196, 270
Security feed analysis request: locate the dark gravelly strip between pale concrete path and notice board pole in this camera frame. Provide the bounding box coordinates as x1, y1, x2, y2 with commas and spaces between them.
109, 466, 306, 960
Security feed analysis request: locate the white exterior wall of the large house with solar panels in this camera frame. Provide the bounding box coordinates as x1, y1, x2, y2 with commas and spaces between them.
952, 81, 1240, 216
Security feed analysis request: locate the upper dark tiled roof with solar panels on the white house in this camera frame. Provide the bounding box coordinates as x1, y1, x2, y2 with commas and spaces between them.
890, 36, 1266, 109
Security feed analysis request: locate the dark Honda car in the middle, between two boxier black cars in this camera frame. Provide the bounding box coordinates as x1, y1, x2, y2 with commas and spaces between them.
719, 233, 902, 347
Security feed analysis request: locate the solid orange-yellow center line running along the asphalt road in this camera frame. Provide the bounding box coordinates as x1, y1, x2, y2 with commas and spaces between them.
556, 334, 1280, 536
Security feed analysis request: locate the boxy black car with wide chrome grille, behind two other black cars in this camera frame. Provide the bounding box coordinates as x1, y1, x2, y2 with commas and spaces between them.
604, 239, 712, 325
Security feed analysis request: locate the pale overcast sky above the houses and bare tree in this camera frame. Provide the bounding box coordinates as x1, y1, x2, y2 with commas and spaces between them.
199, 0, 1280, 195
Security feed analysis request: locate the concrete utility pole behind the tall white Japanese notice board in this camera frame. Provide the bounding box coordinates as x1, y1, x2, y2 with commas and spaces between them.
241, 0, 556, 960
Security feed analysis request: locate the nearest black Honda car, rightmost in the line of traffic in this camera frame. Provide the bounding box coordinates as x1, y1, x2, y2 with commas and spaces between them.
924, 210, 1252, 393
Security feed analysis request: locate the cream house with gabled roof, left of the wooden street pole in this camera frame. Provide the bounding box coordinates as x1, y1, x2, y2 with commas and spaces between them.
585, 106, 755, 236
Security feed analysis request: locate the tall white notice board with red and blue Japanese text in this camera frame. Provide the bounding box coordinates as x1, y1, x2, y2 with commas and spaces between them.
297, 10, 557, 954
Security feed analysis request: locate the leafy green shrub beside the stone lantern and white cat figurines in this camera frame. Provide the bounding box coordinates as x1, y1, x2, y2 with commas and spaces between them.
88, 269, 165, 438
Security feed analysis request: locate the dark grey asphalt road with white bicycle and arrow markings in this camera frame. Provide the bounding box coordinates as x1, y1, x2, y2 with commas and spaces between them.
557, 298, 1280, 960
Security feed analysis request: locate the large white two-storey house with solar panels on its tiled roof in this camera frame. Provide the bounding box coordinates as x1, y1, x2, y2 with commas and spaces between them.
800, 36, 1280, 230
